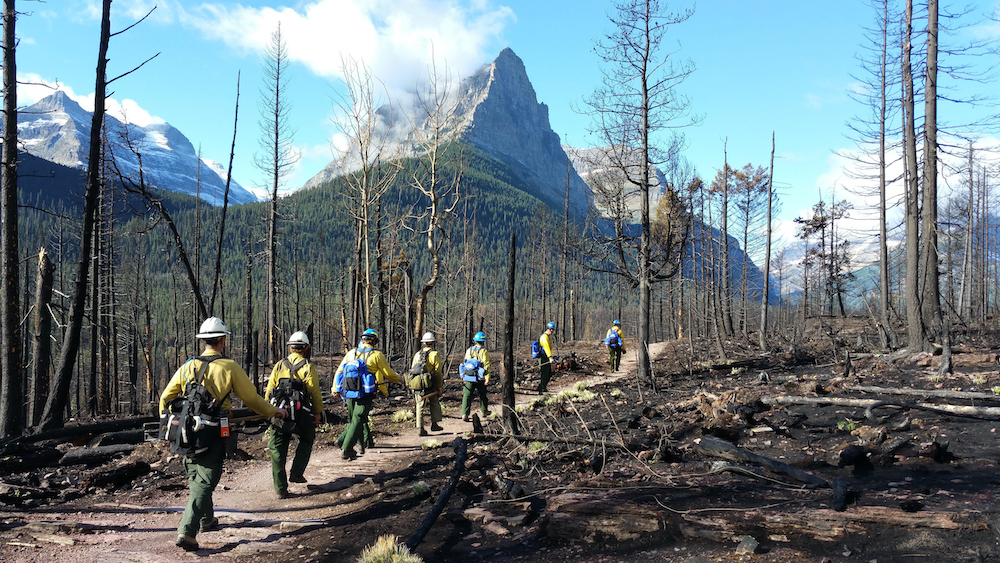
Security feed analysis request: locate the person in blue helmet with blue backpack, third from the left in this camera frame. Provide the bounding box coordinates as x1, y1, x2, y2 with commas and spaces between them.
333, 328, 402, 460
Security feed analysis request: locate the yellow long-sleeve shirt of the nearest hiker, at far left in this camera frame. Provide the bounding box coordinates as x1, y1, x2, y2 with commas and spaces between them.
160, 350, 278, 418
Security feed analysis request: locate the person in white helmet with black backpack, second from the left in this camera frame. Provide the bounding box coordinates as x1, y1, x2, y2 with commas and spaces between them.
264, 331, 323, 498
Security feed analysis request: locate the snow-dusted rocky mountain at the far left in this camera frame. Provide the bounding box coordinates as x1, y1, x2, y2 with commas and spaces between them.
17, 91, 257, 205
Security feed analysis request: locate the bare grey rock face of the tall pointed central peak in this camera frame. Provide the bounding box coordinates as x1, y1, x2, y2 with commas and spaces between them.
306, 49, 589, 214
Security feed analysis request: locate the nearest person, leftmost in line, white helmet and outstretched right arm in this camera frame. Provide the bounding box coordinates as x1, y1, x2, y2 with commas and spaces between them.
160, 317, 288, 551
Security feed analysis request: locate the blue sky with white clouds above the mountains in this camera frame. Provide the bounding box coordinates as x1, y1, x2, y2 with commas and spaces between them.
17, 0, 1000, 251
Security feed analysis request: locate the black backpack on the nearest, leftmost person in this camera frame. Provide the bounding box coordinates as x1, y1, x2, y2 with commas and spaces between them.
161, 356, 228, 456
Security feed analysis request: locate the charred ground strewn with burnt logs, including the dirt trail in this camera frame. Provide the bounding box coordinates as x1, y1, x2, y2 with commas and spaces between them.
0, 319, 1000, 563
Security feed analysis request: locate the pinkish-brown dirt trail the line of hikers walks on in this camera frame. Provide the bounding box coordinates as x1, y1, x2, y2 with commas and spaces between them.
0, 344, 665, 563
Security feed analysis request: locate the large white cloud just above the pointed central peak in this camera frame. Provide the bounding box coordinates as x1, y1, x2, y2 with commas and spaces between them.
174, 0, 514, 96
